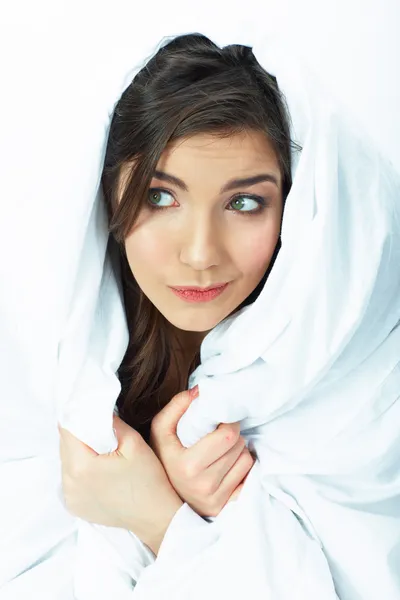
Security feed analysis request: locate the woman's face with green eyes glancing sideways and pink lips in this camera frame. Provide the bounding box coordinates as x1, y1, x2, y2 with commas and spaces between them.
126, 132, 282, 332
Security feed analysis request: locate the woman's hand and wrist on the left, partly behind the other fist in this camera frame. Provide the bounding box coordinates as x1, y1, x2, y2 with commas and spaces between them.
59, 416, 183, 554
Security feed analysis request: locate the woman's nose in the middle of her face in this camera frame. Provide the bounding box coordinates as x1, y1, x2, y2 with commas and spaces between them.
180, 216, 223, 271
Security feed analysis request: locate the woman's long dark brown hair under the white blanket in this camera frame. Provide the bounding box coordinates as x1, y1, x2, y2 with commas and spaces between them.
102, 33, 293, 439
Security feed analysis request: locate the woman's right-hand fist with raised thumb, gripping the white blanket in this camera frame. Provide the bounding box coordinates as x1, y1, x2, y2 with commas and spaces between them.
150, 391, 254, 517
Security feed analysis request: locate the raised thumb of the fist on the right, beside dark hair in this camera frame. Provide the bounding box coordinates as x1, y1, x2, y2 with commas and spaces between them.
152, 385, 199, 448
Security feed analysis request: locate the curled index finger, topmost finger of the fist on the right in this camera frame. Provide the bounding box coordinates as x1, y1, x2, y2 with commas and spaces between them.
186, 422, 240, 471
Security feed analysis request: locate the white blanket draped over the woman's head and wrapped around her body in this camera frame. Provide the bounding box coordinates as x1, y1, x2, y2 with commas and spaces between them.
0, 15, 400, 600
